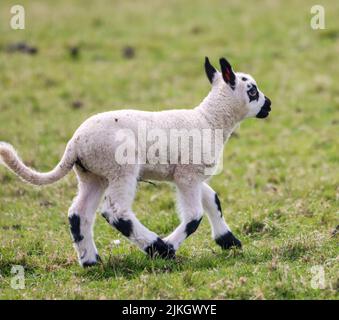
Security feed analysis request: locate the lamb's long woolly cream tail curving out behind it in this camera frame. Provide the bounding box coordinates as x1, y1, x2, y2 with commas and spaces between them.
0, 142, 77, 185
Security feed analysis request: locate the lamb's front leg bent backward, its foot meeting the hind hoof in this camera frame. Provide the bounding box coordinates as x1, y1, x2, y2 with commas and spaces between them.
164, 183, 203, 250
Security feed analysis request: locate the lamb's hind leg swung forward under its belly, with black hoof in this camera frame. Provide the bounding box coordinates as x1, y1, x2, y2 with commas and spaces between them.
101, 175, 174, 258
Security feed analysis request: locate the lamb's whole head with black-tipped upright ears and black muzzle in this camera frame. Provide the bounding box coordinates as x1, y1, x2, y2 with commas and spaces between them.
205, 57, 271, 120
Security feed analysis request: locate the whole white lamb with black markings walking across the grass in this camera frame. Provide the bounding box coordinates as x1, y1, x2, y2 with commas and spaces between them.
0, 57, 271, 267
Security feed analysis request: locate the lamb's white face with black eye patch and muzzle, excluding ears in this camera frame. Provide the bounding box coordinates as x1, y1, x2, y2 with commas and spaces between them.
236, 72, 271, 119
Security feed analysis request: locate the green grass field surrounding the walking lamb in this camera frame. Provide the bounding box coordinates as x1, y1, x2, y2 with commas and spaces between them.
0, 0, 339, 299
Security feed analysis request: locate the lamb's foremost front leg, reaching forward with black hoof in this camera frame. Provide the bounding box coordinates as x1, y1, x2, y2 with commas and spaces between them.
202, 183, 241, 249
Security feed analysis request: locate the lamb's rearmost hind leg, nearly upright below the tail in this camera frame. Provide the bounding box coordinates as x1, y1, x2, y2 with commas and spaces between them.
68, 168, 105, 267
